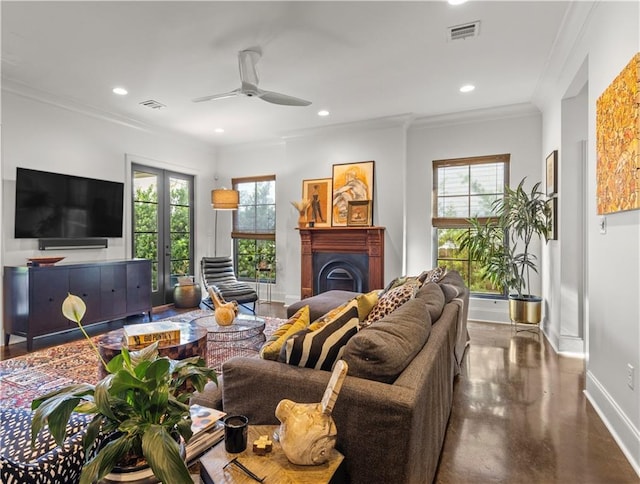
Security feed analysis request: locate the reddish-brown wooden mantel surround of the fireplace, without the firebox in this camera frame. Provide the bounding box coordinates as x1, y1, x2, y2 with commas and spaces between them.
298, 227, 384, 299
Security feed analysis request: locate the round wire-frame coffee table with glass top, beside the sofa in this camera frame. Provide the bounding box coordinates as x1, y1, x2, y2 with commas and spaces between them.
191, 313, 266, 371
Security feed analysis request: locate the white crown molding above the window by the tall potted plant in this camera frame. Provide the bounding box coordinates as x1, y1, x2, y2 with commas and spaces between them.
410, 103, 540, 129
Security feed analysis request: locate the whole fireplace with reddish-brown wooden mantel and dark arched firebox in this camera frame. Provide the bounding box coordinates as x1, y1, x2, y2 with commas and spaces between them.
300, 227, 384, 298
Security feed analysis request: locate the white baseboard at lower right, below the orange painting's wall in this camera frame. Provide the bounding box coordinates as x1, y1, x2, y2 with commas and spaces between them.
584, 371, 640, 477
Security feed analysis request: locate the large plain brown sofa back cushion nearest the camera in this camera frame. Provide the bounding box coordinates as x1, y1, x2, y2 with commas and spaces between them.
342, 298, 431, 383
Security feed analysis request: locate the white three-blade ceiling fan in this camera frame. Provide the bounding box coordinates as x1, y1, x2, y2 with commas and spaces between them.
193, 49, 311, 106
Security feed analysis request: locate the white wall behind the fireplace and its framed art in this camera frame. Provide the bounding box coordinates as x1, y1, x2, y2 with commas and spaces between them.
217, 119, 406, 304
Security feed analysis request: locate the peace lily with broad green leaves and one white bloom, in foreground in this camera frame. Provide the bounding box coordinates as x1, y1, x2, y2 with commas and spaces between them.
31, 294, 217, 484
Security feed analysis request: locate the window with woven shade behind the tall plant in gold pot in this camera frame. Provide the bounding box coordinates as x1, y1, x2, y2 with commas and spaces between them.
431, 154, 510, 295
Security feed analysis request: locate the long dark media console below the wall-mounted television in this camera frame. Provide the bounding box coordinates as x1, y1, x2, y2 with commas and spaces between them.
3, 259, 151, 351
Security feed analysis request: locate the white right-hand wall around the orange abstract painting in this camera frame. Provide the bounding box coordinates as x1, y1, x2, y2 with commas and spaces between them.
540, 2, 640, 474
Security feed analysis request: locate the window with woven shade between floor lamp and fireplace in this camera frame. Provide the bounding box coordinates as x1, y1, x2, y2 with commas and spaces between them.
231, 175, 276, 282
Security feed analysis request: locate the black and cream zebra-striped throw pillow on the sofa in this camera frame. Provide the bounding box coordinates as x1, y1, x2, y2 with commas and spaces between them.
280, 305, 360, 371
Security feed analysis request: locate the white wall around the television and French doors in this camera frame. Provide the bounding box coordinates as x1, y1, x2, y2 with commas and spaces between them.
2, 91, 215, 336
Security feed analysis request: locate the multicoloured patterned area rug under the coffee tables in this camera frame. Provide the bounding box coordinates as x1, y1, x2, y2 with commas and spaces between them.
0, 309, 283, 408
